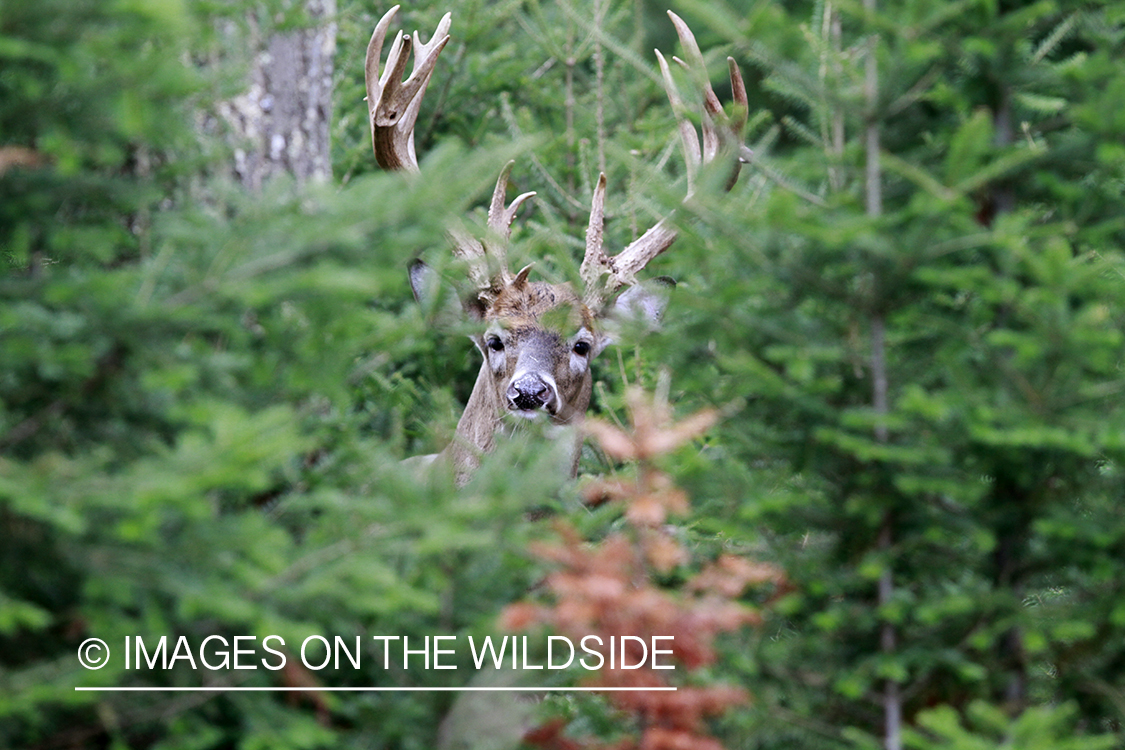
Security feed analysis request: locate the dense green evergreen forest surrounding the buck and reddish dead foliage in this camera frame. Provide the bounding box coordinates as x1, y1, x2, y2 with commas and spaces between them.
0, 0, 1125, 750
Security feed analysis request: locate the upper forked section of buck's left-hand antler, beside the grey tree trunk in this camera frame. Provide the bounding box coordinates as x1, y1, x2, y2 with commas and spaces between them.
363, 6, 451, 172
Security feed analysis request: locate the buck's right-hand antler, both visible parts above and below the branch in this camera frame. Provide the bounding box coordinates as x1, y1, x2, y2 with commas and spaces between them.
579, 10, 748, 309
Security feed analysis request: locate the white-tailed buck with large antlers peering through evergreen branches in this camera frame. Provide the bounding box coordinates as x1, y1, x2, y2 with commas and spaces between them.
365, 6, 747, 484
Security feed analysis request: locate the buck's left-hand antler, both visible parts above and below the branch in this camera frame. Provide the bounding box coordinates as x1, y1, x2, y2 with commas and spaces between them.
363, 6, 536, 298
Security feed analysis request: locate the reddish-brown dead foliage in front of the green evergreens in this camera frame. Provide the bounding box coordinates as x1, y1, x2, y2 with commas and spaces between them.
502, 391, 783, 750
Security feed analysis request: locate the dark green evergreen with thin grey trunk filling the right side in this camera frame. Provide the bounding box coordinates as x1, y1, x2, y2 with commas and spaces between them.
665, 2, 1125, 748
